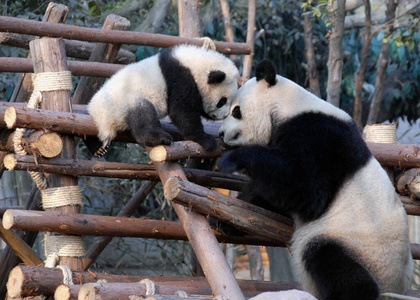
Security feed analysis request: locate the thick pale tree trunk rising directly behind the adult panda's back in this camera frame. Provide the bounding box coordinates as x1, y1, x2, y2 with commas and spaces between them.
327, 0, 346, 107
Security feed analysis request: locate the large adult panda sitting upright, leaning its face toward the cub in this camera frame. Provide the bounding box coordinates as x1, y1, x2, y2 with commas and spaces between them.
218, 60, 413, 300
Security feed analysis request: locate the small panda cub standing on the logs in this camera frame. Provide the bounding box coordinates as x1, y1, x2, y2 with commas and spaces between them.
88, 45, 238, 156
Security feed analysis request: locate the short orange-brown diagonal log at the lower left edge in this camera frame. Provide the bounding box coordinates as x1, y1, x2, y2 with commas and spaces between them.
0, 224, 44, 266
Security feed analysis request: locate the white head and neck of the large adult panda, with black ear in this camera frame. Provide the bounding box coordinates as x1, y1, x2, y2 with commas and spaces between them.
219, 60, 351, 146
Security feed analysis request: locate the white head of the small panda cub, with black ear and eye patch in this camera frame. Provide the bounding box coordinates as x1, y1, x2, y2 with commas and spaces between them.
174, 45, 239, 120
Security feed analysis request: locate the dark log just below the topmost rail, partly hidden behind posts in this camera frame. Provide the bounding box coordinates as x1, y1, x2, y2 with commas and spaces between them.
0, 32, 136, 65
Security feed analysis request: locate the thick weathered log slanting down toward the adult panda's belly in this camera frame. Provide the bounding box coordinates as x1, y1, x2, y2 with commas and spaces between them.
164, 177, 293, 244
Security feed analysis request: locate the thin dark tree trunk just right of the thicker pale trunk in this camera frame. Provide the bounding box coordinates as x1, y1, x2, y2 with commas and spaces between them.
353, 0, 372, 132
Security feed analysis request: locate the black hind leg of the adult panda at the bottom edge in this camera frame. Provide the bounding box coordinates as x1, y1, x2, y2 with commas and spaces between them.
302, 236, 379, 300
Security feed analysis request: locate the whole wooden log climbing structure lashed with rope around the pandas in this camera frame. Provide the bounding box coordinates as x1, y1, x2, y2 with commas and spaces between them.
0, 3, 420, 300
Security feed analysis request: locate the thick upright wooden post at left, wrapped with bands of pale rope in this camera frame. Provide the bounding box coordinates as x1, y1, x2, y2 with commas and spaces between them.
29, 38, 83, 270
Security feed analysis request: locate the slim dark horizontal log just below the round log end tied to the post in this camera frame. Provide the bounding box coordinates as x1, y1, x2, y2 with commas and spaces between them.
4, 154, 249, 191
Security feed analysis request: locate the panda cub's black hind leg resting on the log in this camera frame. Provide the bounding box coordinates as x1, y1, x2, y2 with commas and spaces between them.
126, 100, 173, 147
